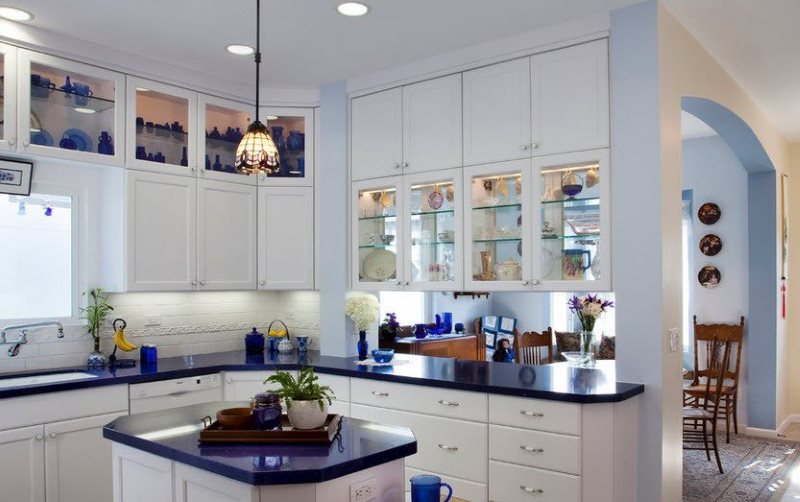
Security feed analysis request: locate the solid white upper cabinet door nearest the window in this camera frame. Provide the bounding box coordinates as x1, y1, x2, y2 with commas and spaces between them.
125, 170, 198, 291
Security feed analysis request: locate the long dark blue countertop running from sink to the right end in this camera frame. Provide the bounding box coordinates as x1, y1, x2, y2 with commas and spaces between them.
0, 351, 644, 403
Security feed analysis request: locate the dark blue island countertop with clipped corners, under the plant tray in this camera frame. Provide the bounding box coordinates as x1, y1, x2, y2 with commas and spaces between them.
103, 402, 417, 485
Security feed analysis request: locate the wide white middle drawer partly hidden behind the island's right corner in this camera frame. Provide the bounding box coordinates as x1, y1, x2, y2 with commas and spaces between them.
350, 404, 489, 483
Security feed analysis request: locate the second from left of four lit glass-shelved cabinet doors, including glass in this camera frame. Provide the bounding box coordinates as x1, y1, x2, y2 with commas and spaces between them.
403, 169, 463, 291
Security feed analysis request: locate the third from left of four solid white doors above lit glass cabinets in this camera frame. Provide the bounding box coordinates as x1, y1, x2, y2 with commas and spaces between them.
464, 58, 531, 165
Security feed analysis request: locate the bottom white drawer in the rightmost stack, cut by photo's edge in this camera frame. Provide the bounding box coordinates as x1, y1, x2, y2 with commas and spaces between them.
489, 461, 581, 502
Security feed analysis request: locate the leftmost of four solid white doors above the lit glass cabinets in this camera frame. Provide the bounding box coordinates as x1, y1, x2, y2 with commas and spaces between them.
350, 87, 403, 180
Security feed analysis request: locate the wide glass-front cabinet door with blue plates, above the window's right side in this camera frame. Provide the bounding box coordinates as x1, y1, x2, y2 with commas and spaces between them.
17, 50, 125, 165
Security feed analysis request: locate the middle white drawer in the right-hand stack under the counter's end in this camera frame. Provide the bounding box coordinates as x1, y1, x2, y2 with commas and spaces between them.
489, 425, 581, 474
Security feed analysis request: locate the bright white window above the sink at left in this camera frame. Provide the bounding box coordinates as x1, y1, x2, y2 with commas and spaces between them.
0, 193, 74, 319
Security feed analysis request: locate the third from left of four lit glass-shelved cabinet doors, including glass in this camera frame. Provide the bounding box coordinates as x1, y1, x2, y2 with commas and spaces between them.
464, 159, 531, 291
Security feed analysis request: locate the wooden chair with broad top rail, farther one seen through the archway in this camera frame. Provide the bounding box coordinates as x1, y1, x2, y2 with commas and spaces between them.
684, 316, 744, 443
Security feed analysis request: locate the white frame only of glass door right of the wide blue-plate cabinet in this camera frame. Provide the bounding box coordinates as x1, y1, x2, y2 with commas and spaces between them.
125, 75, 199, 177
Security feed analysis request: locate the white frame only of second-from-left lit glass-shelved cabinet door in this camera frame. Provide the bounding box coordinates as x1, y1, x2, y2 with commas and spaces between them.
402, 168, 464, 291
